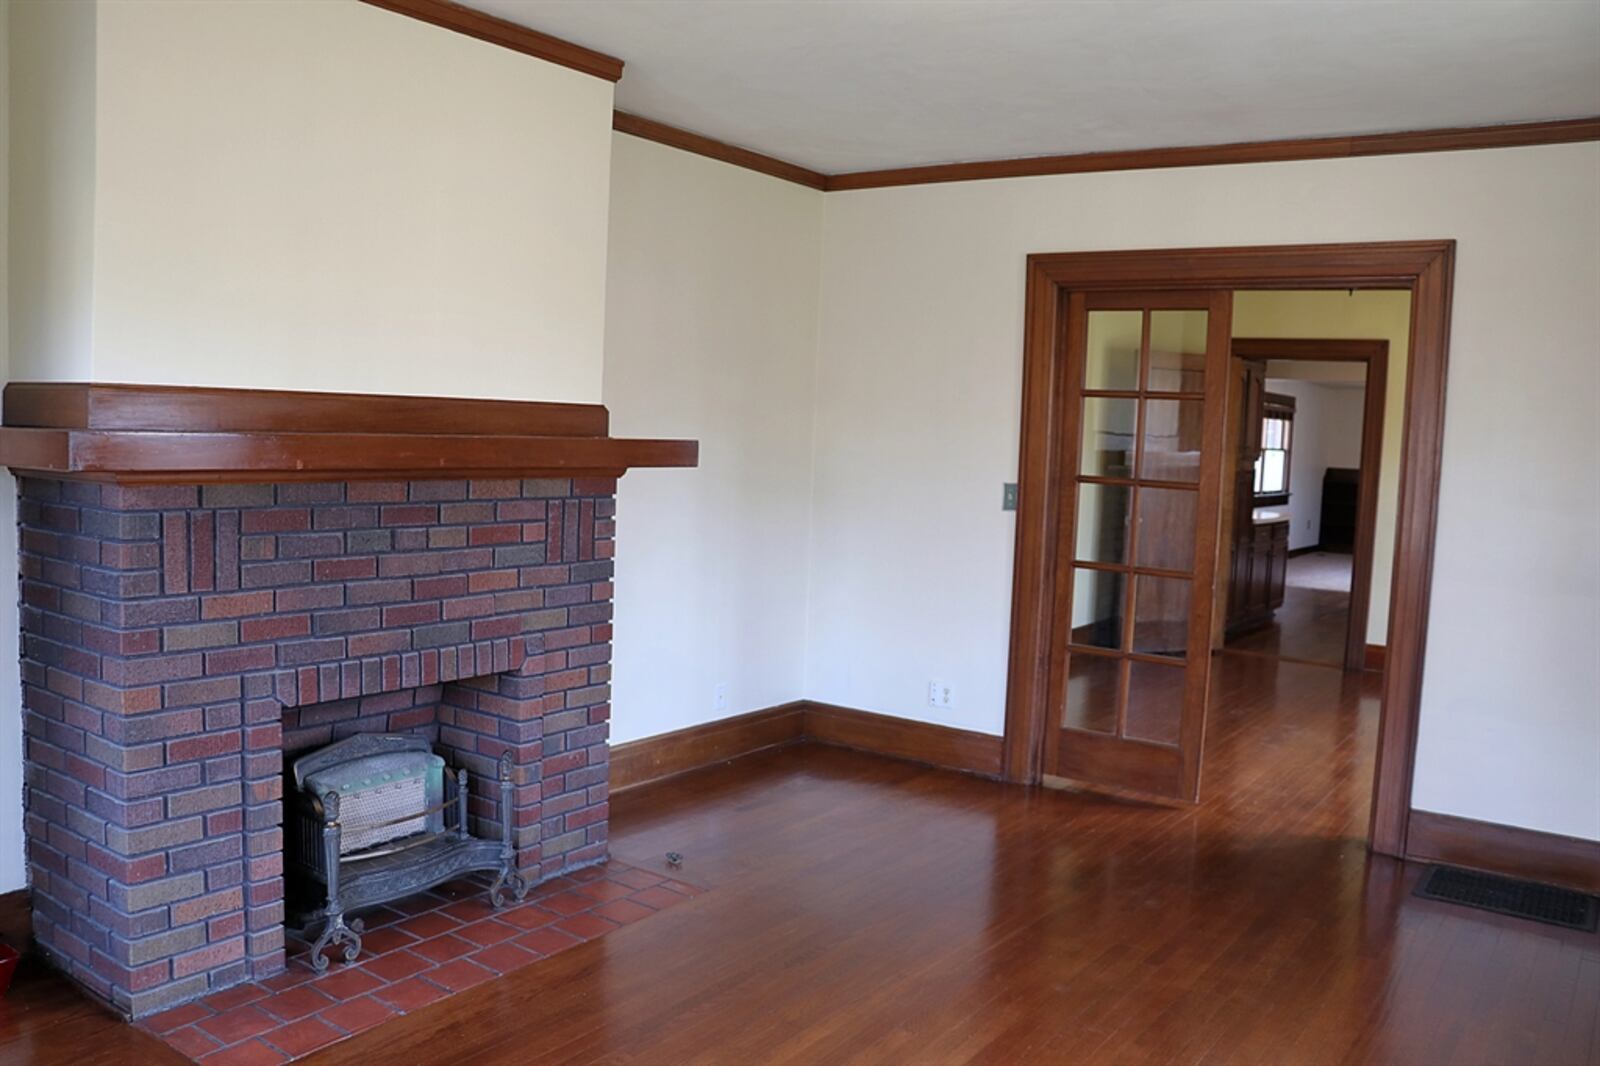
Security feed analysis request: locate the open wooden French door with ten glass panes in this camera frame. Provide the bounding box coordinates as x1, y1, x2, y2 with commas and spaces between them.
1045, 291, 1232, 800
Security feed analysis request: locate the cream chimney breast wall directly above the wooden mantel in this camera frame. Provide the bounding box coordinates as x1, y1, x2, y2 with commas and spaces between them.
14, 0, 611, 402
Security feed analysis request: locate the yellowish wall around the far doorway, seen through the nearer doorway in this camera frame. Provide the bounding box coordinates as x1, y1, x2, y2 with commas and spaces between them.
1234, 290, 1411, 633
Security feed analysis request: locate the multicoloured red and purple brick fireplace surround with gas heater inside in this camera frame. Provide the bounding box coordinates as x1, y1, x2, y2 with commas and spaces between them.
0, 386, 693, 1018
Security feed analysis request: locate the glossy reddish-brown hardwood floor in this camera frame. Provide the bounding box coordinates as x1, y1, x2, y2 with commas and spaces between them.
0, 655, 1600, 1066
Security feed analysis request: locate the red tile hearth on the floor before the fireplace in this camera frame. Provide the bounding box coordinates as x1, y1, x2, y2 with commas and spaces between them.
140, 861, 704, 1066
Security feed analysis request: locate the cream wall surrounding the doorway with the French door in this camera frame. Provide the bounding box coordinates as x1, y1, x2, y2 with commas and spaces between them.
805, 144, 1600, 839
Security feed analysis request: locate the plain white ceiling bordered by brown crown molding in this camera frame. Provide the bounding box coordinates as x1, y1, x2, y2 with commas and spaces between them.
467, 0, 1600, 173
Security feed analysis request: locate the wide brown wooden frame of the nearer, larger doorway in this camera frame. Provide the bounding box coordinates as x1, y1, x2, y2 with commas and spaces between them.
1003, 240, 1456, 856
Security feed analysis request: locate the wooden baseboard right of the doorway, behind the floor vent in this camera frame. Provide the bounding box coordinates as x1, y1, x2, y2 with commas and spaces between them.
1405, 810, 1600, 893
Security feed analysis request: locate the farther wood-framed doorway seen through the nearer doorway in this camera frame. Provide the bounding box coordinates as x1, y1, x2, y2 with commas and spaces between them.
1213, 332, 1410, 671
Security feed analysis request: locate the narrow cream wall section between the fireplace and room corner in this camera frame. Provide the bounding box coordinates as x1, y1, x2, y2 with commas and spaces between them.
605, 134, 822, 743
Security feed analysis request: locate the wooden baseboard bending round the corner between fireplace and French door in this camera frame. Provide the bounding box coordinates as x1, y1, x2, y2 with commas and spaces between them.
611, 699, 1002, 792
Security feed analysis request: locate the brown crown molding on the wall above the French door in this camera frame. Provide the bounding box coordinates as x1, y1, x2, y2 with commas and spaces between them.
827, 117, 1600, 192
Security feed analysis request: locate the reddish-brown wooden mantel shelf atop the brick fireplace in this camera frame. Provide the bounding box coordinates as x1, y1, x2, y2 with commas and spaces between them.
0, 383, 699, 483
